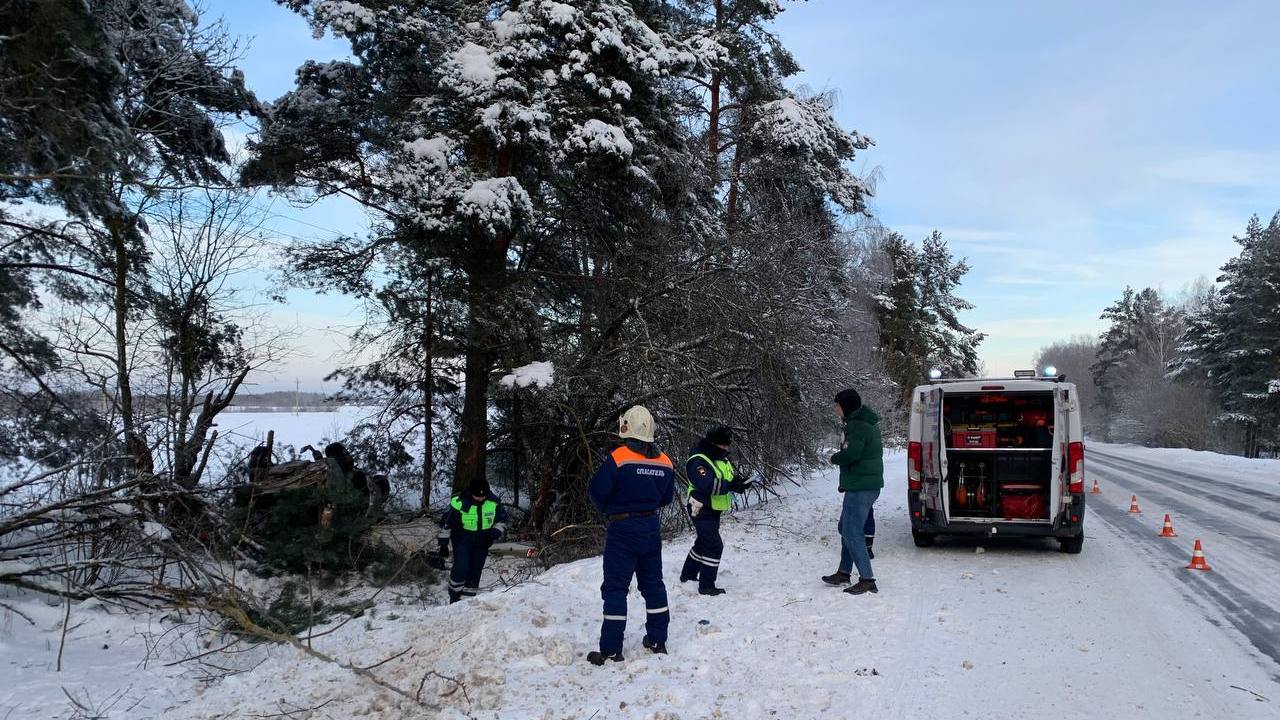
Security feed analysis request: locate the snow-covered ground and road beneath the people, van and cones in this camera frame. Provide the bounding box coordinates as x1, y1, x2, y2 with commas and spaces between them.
0, 446, 1280, 719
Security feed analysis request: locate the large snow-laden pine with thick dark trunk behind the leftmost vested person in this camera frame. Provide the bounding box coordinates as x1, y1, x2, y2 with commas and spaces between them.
244, 0, 694, 486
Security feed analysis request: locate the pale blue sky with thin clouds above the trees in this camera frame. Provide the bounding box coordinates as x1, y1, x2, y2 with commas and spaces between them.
209, 0, 1280, 387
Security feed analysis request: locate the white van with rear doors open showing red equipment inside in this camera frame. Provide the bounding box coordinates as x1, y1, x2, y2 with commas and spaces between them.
908, 370, 1084, 553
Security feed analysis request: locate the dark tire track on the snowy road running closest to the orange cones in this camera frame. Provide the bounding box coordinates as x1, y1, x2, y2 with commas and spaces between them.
1091, 471, 1280, 683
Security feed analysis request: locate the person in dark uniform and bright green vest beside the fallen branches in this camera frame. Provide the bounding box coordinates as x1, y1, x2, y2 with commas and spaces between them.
440, 480, 507, 605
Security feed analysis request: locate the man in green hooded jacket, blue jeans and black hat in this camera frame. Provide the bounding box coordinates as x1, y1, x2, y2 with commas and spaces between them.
822, 388, 884, 594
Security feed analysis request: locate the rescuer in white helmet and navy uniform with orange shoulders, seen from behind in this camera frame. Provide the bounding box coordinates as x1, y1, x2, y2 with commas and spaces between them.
586, 405, 676, 665
